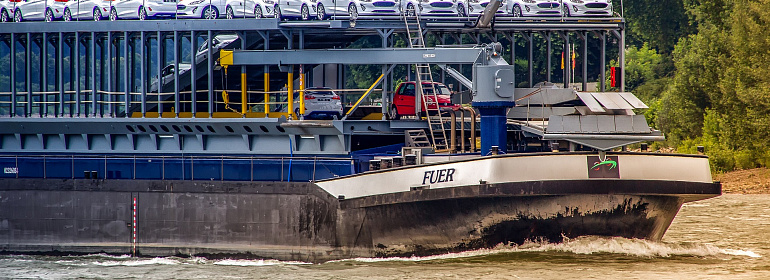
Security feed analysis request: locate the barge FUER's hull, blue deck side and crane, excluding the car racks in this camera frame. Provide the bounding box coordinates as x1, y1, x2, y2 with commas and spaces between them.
0, 34, 721, 262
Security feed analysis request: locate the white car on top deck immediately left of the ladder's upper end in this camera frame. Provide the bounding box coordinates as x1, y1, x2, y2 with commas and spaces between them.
316, 0, 401, 19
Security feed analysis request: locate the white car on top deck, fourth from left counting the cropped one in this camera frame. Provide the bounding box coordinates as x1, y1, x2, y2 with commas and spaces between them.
108, 0, 176, 20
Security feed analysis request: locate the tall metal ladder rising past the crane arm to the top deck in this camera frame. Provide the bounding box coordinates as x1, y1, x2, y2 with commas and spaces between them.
402, 10, 449, 153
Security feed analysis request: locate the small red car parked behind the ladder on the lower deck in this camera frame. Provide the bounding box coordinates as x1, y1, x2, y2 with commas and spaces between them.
388, 82, 460, 120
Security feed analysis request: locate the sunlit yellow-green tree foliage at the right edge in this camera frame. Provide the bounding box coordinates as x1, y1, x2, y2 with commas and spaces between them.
656, 0, 770, 171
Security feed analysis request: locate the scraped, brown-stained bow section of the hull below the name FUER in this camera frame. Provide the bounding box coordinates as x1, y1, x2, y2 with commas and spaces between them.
342, 195, 683, 257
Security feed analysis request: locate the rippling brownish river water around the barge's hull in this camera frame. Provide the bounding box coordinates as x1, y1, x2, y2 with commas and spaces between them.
0, 195, 770, 280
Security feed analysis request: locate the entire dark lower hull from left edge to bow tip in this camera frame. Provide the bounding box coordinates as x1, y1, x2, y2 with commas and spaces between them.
0, 179, 721, 262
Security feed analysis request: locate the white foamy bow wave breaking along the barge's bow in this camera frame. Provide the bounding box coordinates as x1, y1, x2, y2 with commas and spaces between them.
332, 236, 762, 262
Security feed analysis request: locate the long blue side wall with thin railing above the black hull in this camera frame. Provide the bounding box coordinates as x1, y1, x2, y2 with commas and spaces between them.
0, 155, 355, 182
